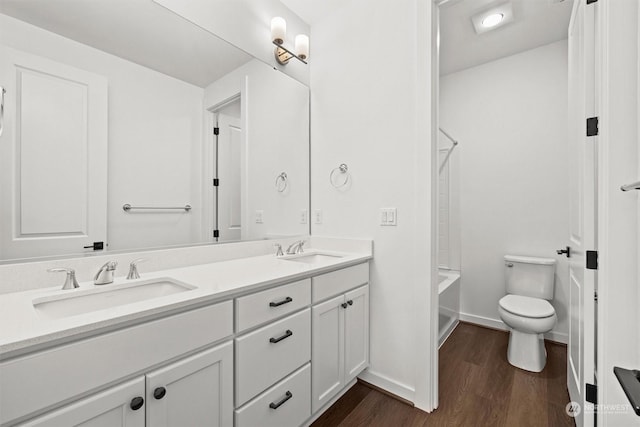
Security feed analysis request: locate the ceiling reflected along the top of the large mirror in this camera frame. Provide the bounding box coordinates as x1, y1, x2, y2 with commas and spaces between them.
0, 0, 252, 87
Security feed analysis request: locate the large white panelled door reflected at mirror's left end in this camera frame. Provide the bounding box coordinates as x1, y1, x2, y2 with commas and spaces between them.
0, 46, 107, 259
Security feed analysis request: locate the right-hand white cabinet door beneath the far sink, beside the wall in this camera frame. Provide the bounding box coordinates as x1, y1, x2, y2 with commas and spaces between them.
344, 285, 369, 384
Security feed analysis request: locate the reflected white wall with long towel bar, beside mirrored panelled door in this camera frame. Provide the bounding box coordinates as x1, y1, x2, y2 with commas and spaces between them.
0, 15, 203, 249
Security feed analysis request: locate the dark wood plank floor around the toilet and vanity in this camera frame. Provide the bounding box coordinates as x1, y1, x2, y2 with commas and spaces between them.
312, 323, 575, 427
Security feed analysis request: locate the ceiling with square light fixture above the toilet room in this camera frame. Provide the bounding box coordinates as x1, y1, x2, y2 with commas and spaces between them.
440, 0, 573, 75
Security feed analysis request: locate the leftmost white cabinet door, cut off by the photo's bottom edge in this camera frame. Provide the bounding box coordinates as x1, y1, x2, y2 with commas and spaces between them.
21, 377, 146, 427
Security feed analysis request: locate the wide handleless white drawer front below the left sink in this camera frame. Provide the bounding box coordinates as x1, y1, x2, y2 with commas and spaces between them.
0, 301, 233, 425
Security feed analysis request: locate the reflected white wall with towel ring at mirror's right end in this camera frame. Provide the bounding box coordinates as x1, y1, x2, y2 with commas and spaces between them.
204, 59, 309, 239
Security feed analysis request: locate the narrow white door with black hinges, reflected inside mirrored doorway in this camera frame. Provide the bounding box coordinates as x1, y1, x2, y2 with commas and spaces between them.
217, 108, 242, 241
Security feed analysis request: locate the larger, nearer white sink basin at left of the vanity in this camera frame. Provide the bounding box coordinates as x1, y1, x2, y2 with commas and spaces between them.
33, 277, 196, 319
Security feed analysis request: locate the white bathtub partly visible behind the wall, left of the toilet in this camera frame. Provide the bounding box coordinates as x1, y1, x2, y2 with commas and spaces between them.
438, 270, 460, 347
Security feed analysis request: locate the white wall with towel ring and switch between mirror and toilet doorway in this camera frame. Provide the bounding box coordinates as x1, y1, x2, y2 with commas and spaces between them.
311, 0, 437, 410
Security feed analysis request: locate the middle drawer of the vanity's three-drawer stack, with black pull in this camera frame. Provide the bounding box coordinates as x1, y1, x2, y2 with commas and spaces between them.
235, 309, 311, 406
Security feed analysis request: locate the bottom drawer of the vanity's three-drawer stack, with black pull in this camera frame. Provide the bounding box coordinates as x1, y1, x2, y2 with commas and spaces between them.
235, 363, 311, 427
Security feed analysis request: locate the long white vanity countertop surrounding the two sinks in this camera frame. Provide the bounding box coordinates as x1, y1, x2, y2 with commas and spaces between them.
0, 249, 372, 360
